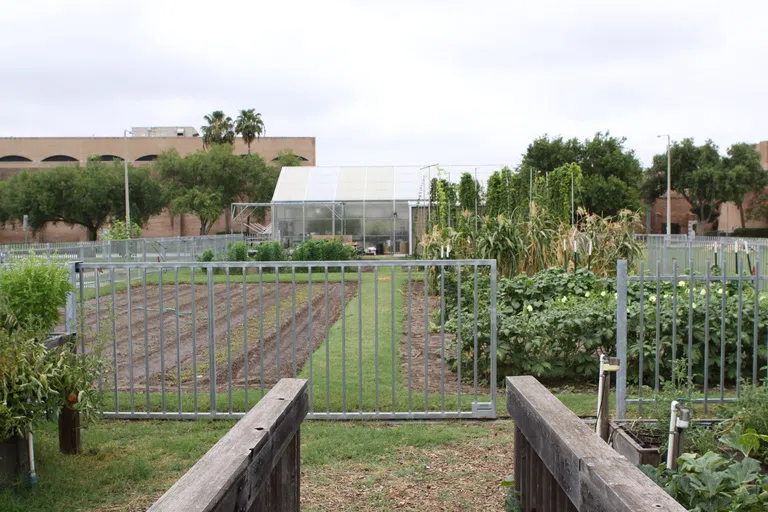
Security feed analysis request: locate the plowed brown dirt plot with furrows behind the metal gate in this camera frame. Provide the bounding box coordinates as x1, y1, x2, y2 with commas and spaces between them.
85, 277, 357, 392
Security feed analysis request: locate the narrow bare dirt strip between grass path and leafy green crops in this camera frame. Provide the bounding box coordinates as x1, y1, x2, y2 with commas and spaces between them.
400, 282, 489, 395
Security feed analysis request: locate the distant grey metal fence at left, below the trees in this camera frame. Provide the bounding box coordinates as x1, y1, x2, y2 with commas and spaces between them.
0, 234, 243, 263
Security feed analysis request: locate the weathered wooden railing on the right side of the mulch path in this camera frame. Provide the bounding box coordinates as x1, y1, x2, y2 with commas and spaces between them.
507, 376, 685, 512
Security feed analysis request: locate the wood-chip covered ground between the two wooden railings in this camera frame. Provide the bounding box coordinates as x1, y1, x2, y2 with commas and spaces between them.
301, 425, 514, 511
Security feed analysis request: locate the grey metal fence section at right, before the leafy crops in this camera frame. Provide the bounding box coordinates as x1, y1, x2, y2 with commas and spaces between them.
616, 251, 768, 418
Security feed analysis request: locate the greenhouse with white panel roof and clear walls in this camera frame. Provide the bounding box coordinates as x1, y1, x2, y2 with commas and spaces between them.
232, 166, 499, 254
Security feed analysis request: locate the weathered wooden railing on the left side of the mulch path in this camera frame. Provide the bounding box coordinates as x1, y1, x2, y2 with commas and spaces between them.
149, 379, 308, 512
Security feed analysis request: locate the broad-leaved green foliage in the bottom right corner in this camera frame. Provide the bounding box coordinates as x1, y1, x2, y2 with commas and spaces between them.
641, 452, 768, 512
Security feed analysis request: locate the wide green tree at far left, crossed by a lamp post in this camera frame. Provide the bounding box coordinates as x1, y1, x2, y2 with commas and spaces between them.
3, 158, 165, 240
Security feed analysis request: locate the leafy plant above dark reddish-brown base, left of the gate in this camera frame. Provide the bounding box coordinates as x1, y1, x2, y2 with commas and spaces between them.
48, 341, 103, 455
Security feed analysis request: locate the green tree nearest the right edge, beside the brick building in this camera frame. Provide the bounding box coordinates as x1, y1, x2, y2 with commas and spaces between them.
723, 142, 768, 228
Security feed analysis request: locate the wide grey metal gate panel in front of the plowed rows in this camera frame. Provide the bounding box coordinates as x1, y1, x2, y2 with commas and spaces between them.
72, 260, 496, 419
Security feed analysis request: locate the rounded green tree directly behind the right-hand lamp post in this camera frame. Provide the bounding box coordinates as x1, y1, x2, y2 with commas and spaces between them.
645, 138, 730, 229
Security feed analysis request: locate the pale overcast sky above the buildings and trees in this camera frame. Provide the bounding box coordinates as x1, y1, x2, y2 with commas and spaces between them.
0, 0, 768, 169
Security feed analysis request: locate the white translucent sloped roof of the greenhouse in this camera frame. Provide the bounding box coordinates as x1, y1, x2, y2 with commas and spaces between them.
272, 165, 501, 203
